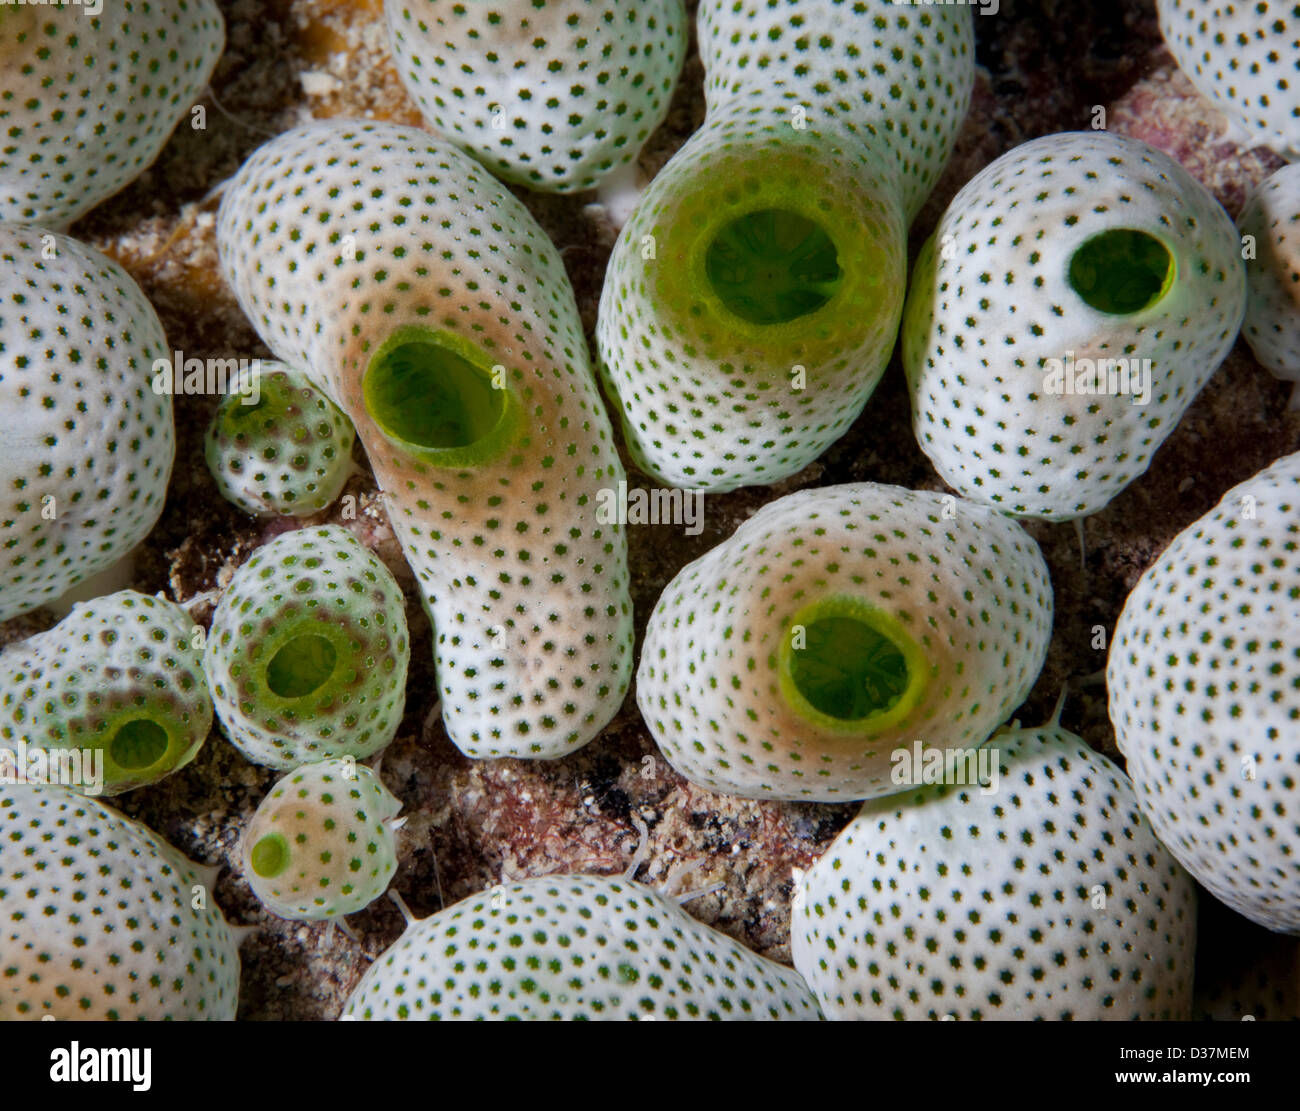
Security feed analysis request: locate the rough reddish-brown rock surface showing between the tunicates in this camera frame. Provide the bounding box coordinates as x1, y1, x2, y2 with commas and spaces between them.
0, 0, 1300, 1020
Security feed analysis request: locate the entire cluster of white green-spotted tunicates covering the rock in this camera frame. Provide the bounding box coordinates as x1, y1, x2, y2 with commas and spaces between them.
0, 0, 1300, 1020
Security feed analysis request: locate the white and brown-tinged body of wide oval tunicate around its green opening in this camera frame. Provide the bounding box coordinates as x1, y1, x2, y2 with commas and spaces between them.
637, 482, 1052, 802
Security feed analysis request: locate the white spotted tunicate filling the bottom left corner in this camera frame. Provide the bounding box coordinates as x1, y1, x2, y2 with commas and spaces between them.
0, 785, 239, 1021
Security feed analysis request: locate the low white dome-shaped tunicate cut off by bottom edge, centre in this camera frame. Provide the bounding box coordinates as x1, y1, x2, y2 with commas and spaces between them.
343, 876, 820, 1021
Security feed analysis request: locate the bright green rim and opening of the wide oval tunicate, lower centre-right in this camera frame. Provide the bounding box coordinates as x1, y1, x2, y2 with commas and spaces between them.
779, 596, 930, 733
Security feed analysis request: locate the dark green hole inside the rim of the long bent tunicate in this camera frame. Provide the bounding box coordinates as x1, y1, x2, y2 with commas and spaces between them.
365, 340, 506, 448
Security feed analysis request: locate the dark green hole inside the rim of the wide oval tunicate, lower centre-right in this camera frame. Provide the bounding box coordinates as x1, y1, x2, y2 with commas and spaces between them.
790, 617, 910, 721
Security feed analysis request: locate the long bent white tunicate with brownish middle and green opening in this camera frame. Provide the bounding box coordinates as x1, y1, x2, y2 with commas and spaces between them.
217, 120, 632, 758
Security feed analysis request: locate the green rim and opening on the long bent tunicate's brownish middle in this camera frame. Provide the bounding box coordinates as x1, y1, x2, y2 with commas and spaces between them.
361, 327, 520, 466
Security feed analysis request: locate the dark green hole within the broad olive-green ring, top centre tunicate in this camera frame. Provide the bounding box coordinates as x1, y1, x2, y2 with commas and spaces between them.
705, 208, 844, 324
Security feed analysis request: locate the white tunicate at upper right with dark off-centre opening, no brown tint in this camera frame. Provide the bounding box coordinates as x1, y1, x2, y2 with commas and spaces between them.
902, 131, 1245, 520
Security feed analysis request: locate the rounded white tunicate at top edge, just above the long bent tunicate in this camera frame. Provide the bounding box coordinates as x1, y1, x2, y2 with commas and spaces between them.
385, 0, 686, 192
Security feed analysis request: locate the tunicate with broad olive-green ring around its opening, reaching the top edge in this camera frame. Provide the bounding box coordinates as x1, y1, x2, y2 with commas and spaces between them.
597, 0, 975, 491
